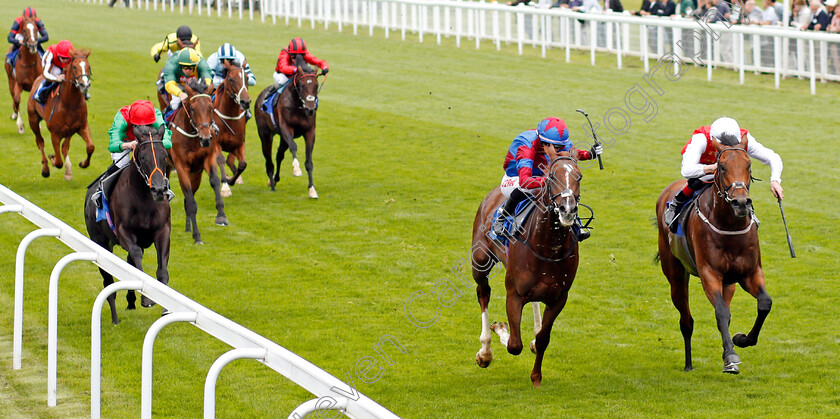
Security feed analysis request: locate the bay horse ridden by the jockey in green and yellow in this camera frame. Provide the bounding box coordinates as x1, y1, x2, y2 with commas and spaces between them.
169, 78, 228, 244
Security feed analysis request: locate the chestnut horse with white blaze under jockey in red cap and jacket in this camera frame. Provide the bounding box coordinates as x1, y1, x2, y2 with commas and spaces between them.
26, 49, 94, 180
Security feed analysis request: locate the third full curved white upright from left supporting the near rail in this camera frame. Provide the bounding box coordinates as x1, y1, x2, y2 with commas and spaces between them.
90, 281, 143, 419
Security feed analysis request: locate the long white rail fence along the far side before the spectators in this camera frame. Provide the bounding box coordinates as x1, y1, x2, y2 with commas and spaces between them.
79, 0, 840, 94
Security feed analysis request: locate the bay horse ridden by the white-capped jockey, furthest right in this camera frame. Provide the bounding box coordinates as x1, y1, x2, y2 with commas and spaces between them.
656, 136, 772, 374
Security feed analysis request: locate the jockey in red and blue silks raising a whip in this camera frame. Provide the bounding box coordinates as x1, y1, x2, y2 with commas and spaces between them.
493, 117, 604, 241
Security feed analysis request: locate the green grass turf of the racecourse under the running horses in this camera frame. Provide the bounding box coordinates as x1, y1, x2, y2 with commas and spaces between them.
0, 0, 840, 418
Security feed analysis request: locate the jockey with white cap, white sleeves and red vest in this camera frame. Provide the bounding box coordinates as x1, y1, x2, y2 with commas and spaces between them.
664, 116, 785, 225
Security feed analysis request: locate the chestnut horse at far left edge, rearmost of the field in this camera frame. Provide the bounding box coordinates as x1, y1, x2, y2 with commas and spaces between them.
6, 17, 44, 134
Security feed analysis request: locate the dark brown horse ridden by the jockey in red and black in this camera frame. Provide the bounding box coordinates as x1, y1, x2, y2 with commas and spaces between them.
255, 55, 320, 198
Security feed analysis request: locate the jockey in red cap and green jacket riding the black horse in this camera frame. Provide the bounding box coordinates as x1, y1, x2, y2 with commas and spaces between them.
92, 100, 173, 208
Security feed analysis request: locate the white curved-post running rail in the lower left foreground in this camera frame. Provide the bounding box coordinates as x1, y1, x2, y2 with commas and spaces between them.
0, 185, 397, 419
